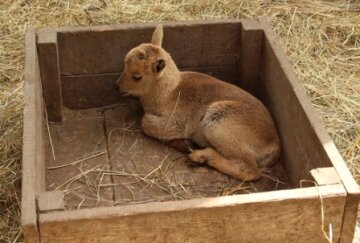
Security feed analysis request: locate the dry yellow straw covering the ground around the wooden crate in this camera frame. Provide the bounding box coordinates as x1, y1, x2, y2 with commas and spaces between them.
0, 0, 360, 242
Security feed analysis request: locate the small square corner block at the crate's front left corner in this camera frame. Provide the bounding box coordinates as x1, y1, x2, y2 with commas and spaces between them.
36, 191, 65, 213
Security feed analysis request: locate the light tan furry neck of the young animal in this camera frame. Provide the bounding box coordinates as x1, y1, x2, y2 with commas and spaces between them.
140, 61, 181, 115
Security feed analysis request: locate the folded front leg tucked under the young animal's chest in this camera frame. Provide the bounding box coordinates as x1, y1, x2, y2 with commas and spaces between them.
141, 113, 185, 141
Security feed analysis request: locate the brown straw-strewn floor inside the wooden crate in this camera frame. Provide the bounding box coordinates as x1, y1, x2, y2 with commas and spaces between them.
46, 100, 290, 209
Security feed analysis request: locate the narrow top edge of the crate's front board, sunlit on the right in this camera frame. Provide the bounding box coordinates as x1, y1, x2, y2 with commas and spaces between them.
40, 184, 346, 220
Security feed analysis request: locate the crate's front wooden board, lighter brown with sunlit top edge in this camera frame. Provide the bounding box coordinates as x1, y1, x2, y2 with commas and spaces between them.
40, 185, 346, 242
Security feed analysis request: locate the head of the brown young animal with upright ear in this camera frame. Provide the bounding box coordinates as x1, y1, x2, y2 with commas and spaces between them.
115, 25, 169, 96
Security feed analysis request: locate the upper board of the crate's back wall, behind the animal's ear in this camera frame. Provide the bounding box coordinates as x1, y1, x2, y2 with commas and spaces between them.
52, 20, 241, 75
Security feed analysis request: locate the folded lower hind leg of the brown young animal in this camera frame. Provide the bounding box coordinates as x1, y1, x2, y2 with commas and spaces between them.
189, 148, 261, 181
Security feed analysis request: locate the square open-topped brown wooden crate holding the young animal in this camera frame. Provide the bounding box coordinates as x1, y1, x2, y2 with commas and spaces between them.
21, 18, 359, 242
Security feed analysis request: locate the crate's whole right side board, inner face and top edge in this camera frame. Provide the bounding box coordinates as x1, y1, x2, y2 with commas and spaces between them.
260, 18, 360, 242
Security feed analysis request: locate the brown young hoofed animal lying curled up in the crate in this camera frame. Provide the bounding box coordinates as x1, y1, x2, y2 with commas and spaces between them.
115, 25, 280, 181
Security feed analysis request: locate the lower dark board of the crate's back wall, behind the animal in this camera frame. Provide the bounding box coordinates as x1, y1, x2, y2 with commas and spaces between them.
61, 65, 237, 109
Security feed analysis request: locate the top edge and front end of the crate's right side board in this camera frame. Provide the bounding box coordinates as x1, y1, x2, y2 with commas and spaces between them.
259, 17, 360, 242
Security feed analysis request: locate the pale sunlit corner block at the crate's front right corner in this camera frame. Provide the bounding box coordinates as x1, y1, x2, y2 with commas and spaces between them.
310, 167, 341, 186
